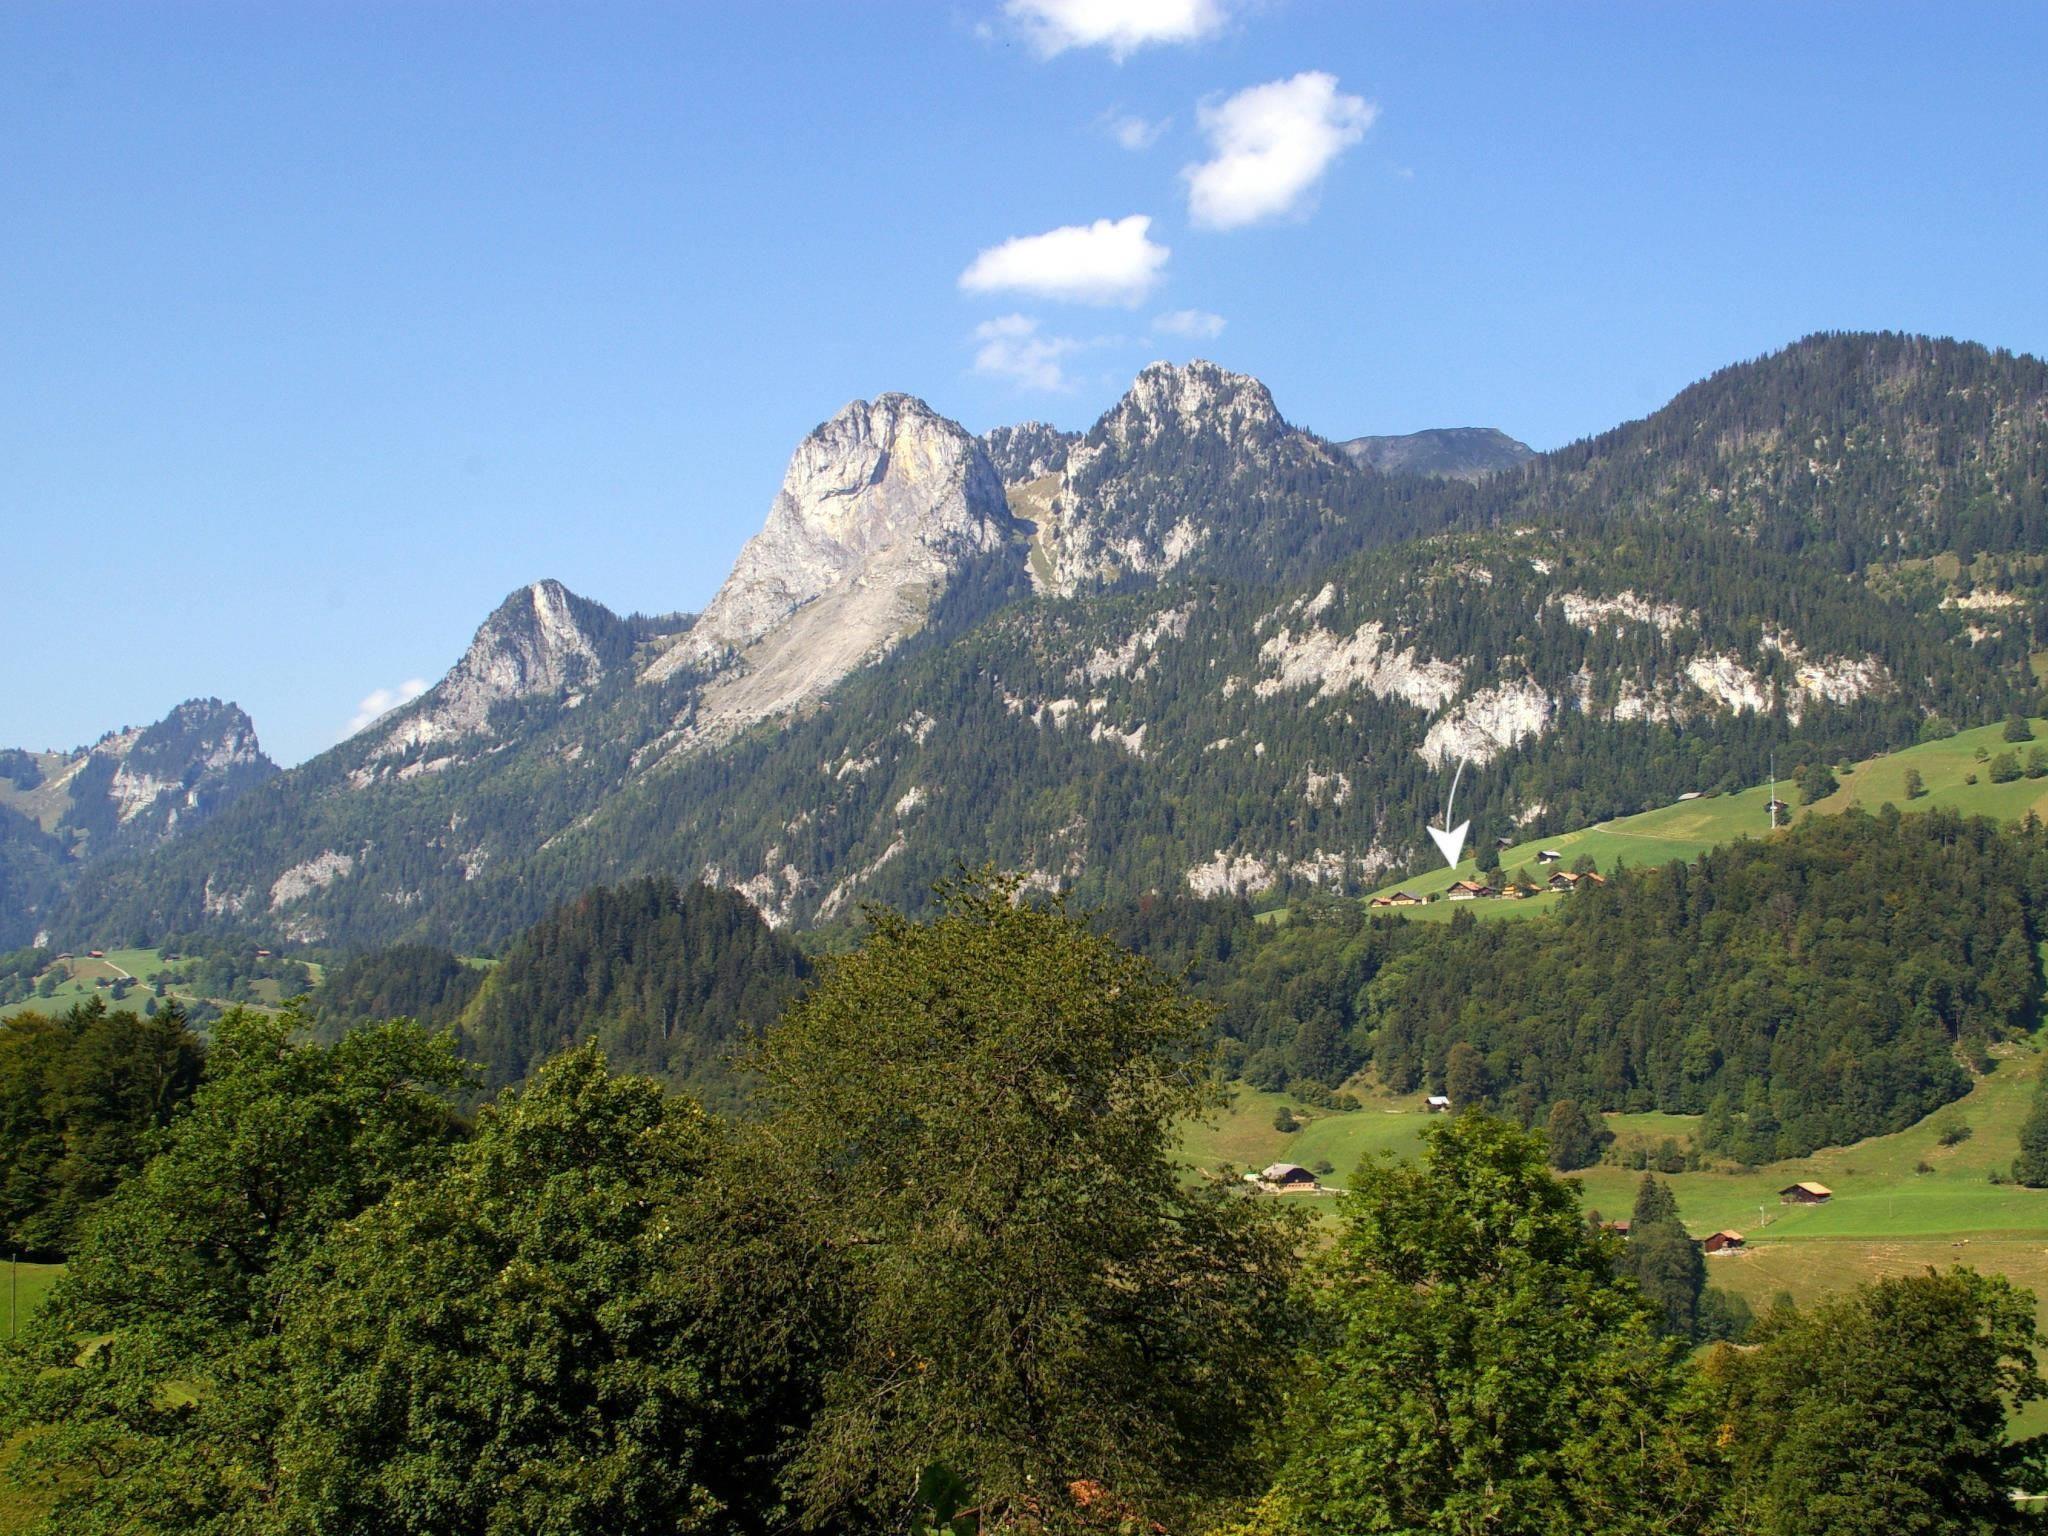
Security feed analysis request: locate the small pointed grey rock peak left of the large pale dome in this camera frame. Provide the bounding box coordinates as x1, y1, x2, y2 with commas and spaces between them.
369, 582, 633, 758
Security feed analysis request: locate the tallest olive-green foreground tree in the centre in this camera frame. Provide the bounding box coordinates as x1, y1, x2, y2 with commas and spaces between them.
756, 874, 1296, 1528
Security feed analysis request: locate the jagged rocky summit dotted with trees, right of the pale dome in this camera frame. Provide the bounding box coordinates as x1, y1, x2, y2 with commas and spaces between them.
1032, 360, 1348, 594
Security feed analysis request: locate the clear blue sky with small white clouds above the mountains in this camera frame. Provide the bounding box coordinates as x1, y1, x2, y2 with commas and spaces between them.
0, 0, 2048, 762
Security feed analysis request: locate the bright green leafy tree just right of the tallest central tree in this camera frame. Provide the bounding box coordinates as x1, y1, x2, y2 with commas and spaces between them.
1251, 1114, 1712, 1536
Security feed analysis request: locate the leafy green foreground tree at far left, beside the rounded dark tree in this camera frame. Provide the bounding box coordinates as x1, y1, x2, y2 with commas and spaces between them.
0, 1010, 463, 1536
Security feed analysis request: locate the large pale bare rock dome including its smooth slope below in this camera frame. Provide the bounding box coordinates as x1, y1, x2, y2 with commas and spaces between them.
645, 393, 1016, 743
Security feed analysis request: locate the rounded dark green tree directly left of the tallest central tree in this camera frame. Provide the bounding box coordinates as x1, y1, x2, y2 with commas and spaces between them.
281, 1047, 823, 1536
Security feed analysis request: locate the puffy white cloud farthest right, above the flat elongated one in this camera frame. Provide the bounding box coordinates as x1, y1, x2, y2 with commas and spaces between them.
1182, 70, 1378, 229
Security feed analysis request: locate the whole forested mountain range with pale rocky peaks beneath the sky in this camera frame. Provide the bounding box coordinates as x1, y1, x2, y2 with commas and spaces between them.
0, 334, 2048, 948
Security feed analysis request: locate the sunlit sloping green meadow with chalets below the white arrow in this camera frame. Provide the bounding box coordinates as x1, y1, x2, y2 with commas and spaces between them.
1374, 719, 2048, 922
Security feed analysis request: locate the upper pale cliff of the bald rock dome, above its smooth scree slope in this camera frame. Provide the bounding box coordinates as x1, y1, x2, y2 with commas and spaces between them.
649, 393, 1012, 678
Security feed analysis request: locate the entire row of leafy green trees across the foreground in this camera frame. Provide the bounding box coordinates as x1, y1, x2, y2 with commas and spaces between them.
0, 877, 2048, 1536
